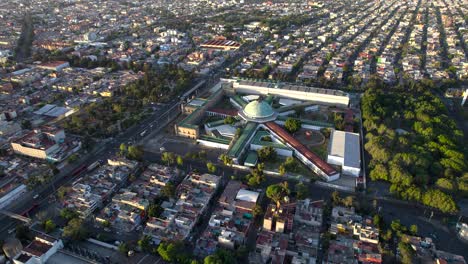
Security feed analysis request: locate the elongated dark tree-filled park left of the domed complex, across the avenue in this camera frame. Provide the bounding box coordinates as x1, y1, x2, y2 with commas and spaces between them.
63, 65, 193, 138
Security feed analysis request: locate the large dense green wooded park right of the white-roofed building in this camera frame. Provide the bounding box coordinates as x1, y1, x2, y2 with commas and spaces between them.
362, 89, 468, 213
